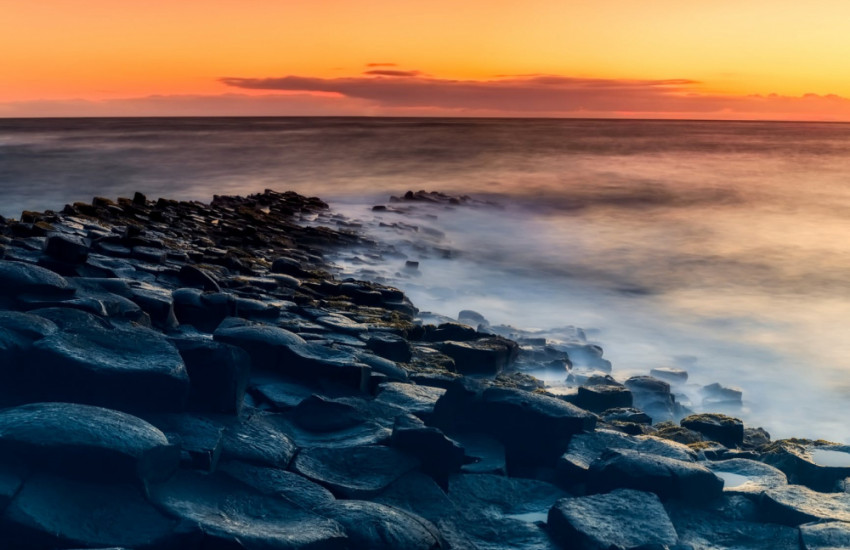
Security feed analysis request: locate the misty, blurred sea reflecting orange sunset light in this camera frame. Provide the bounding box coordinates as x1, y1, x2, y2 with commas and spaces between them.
0, 118, 850, 442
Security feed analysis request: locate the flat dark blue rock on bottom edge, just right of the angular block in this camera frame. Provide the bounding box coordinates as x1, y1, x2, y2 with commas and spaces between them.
667, 496, 800, 550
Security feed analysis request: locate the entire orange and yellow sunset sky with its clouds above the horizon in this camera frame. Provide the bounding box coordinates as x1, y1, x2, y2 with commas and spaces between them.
0, 0, 850, 120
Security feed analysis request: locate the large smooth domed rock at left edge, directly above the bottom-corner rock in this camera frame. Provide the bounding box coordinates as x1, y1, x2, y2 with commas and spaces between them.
0, 403, 180, 482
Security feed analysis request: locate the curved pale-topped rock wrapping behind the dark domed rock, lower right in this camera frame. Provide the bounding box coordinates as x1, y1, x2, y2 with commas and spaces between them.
556, 430, 696, 485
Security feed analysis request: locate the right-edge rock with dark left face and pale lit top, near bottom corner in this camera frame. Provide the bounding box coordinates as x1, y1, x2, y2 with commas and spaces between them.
759, 485, 850, 525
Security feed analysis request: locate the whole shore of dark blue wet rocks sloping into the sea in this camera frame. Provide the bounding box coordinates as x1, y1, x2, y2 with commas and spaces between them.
0, 191, 850, 550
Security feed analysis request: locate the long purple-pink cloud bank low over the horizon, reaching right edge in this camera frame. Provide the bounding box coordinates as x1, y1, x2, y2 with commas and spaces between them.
215, 70, 850, 119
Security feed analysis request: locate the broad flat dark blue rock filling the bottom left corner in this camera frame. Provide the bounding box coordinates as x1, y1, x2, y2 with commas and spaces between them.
0, 475, 186, 550
